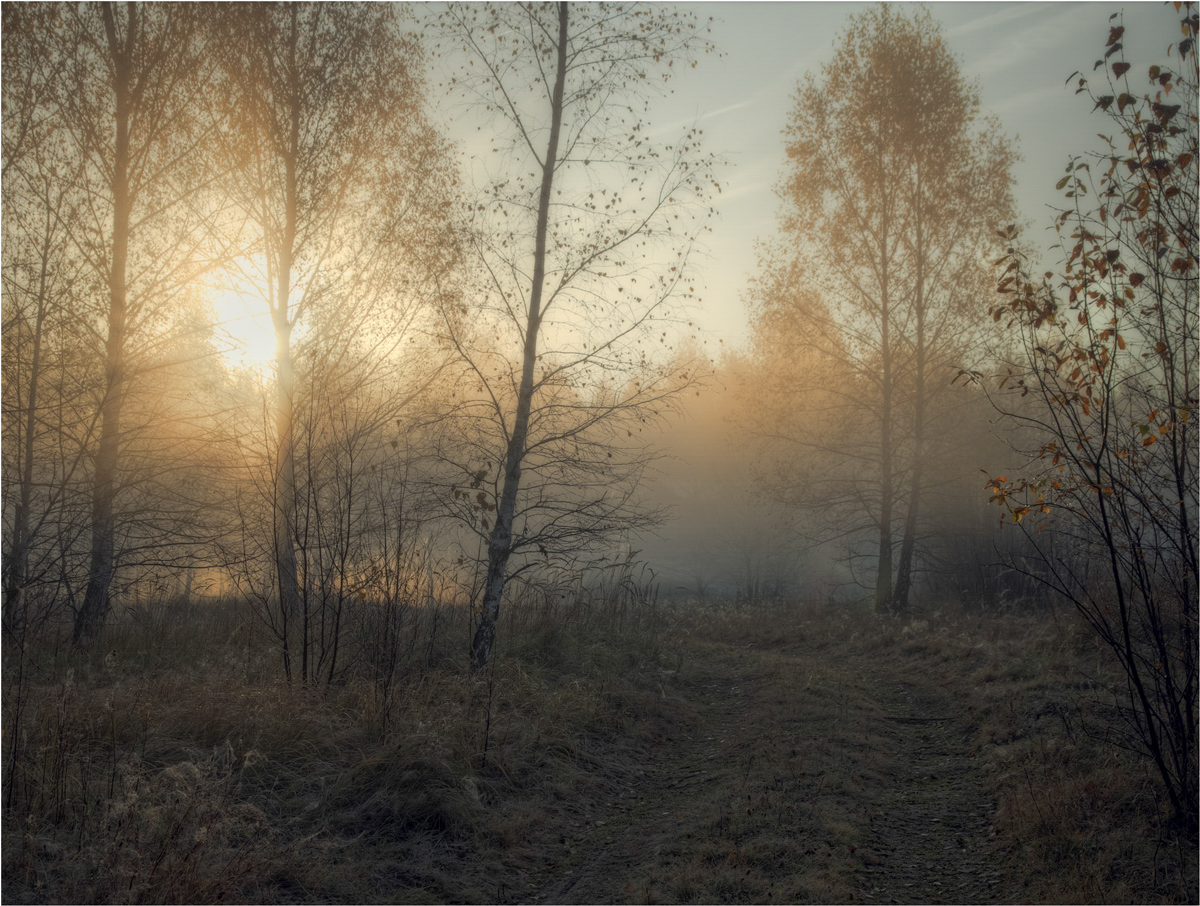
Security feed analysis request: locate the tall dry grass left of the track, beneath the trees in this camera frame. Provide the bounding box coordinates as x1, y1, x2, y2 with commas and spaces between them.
2, 583, 659, 902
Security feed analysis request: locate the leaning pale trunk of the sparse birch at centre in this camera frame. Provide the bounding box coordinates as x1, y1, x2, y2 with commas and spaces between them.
470, 2, 568, 673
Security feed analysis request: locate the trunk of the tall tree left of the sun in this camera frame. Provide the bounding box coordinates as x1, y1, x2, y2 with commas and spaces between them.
73, 4, 139, 644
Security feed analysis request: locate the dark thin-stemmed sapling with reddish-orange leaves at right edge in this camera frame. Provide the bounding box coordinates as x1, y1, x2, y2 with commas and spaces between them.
989, 4, 1200, 829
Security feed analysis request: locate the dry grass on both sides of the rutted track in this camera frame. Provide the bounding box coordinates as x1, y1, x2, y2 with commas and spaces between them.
2, 588, 1196, 902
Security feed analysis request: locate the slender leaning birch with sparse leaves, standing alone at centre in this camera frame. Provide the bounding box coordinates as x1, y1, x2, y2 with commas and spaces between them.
443, 2, 712, 671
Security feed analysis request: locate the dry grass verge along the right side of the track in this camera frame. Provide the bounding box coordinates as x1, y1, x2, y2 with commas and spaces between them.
662, 604, 1200, 902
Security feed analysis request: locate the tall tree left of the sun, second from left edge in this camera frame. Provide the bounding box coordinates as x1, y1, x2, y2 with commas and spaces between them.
35, 4, 225, 643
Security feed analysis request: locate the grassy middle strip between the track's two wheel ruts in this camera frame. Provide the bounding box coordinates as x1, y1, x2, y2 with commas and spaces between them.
600, 643, 864, 902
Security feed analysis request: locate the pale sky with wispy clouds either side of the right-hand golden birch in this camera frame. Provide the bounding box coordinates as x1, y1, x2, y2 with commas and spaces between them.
580, 2, 1178, 344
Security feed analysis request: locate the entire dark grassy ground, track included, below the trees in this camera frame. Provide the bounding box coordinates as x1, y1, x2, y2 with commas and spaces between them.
2, 600, 1200, 902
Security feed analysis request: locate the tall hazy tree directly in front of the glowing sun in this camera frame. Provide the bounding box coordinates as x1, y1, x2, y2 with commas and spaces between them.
222, 4, 457, 682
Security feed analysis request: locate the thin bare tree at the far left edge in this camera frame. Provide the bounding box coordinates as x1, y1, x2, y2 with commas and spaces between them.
0, 76, 96, 641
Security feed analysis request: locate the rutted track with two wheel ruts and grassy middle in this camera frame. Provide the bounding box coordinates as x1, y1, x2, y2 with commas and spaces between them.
532, 646, 1019, 902
